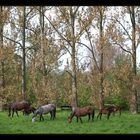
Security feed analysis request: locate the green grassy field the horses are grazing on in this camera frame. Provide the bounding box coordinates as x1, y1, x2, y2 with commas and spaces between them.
0, 110, 140, 134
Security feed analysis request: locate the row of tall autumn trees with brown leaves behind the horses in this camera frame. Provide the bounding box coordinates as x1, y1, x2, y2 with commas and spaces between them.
0, 6, 140, 114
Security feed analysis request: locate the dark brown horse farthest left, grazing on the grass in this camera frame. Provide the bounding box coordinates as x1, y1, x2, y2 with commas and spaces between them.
8, 101, 30, 117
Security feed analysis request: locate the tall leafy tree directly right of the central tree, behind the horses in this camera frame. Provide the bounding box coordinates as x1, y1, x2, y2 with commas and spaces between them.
79, 6, 107, 108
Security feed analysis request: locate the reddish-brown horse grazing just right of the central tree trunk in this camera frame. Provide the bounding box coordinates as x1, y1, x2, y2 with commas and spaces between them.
68, 106, 95, 123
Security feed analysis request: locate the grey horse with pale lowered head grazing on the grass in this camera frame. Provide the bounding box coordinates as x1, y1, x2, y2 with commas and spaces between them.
32, 104, 56, 121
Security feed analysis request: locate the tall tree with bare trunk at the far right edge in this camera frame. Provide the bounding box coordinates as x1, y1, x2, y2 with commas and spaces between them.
110, 6, 140, 114
